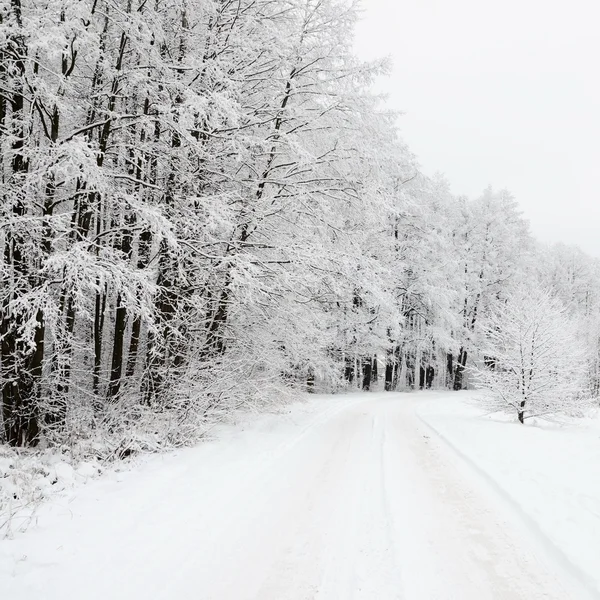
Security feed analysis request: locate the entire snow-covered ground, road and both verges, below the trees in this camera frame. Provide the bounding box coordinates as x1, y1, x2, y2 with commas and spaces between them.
0, 392, 600, 600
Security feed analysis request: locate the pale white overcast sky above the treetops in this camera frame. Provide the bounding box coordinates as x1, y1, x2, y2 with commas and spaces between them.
356, 0, 600, 257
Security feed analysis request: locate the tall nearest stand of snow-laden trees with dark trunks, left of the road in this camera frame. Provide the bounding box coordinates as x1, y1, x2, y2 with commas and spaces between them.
0, 0, 420, 446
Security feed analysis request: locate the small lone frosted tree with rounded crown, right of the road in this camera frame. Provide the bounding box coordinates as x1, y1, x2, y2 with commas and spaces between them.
472, 289, 586, 423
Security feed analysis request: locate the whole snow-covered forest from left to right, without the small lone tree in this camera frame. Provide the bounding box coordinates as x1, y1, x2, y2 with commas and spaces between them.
0, 0, 600, 452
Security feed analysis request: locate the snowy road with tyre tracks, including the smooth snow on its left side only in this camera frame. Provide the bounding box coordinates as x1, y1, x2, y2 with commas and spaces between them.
0, 394, 592, 600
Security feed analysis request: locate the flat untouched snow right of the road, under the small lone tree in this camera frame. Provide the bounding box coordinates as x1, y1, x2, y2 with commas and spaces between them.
417, 392, 600, 597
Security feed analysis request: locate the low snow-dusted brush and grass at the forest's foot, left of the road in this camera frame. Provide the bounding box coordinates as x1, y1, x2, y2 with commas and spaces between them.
0, 394, 348, 540
